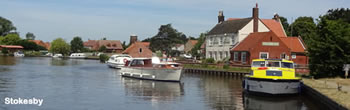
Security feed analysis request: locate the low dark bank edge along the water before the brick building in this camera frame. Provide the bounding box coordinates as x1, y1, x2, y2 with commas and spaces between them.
183, 64, 250, 72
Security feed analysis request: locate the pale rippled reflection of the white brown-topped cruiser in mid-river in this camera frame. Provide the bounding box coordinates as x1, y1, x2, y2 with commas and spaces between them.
121, 77, 184, 102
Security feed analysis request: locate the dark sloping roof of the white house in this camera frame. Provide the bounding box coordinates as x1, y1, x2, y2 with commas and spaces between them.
208, 18, 252, 35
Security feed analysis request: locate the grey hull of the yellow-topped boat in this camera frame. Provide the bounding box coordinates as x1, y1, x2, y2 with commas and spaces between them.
243, 77, 301, 95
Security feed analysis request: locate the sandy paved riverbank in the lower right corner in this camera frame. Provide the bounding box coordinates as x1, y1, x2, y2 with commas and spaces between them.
303, 78, 350, 109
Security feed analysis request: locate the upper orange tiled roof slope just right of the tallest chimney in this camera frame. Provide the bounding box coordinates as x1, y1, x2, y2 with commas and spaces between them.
260, 19, 287, 37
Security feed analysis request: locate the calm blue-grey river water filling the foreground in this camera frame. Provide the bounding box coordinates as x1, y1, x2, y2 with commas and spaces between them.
0, 56, 320, 110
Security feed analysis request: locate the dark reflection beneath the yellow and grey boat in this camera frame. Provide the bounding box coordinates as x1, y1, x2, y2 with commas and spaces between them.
243, 95, 307, 110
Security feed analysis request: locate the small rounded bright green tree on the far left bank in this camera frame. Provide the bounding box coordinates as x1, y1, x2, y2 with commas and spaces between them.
50, 38, 70, 55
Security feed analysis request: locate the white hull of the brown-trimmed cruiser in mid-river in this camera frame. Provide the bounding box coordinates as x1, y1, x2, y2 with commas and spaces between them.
121, 67, 182, 82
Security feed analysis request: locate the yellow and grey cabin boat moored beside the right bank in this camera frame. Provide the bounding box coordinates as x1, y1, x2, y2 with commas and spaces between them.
242, 59, 301, 95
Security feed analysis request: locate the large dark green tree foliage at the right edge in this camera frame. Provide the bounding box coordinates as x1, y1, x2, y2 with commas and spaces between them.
308, 16, 350, 78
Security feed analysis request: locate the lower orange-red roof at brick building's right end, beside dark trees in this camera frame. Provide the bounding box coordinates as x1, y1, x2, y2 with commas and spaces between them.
281, 37, 306, 52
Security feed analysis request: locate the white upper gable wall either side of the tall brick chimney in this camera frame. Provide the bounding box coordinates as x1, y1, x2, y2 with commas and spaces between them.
238, 19, 270, 42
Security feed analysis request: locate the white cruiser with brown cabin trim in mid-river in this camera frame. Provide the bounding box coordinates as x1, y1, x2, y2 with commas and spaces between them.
121, 57, 182, 82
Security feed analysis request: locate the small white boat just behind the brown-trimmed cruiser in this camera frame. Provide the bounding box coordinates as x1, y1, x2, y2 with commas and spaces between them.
107, 54, 131, 69
